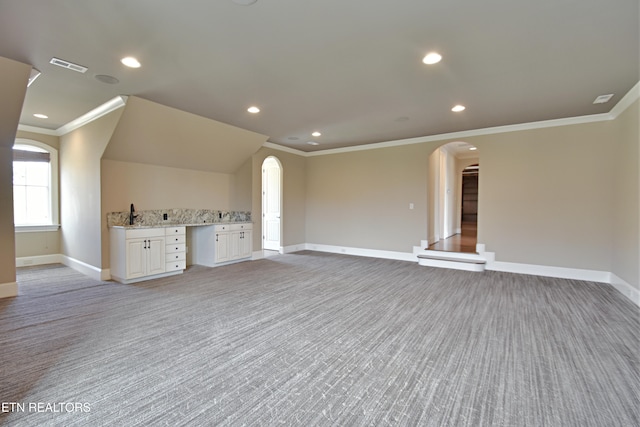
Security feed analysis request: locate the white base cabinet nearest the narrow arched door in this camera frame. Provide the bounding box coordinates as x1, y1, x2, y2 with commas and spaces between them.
192, 223, 252, 267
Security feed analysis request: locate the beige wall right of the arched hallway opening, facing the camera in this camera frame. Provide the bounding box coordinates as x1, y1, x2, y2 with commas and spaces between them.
467, 122, 614, 271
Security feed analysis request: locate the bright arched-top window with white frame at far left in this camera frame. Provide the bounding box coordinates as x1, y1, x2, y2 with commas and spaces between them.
13, 139, 58, 231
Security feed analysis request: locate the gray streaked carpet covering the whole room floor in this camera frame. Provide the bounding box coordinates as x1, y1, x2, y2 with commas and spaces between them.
0, 252, 640, 426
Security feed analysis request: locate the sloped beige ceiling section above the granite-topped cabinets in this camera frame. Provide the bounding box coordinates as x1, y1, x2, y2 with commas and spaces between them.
102, 96, 267, 173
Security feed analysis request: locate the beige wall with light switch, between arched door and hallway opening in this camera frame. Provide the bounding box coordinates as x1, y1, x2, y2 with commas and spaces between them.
306, 143, 439, 252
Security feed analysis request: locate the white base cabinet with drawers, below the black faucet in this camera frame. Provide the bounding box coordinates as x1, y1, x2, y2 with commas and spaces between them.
109, 227, 184, 283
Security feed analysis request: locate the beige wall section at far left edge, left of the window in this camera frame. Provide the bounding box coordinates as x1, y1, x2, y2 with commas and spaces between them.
0, 57, 31, 297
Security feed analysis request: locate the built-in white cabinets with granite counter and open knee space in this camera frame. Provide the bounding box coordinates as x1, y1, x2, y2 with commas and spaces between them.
107, 209, 253, 283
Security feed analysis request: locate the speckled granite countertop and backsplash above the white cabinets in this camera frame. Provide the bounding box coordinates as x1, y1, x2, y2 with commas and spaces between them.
107, 209, 251, 228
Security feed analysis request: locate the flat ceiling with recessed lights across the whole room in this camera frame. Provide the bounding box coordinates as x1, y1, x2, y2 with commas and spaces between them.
0, 0, 640, 151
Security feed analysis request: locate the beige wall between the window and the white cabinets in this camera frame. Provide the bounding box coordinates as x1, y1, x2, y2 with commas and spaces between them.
60, 109, 122, 268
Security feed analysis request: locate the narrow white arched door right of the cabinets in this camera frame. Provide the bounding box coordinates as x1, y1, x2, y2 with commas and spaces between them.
262, 157, 282, 251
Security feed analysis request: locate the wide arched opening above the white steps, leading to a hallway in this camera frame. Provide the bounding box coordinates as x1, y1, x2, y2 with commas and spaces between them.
427, 141, 479, 252
